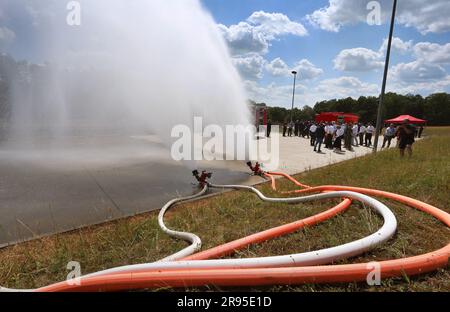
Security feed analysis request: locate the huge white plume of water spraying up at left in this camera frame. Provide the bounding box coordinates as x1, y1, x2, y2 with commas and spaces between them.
0, 0, 249, 168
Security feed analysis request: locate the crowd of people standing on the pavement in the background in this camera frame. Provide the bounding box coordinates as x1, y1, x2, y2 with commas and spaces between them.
267, 120, 423, 157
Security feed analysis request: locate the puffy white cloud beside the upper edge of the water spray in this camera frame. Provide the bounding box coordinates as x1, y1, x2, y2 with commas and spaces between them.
219, 11, 308, 55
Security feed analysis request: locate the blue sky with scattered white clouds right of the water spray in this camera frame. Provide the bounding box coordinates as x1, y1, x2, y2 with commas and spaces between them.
202, 0, 450, 107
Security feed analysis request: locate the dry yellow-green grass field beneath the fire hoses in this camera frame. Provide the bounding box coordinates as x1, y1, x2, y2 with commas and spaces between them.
0, 127, 450, 291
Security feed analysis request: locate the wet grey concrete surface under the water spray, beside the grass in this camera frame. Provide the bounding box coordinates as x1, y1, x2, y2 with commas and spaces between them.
0, 138, 258, 247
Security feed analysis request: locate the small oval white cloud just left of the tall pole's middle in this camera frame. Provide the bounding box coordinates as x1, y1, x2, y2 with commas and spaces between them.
334, 48, 383, 72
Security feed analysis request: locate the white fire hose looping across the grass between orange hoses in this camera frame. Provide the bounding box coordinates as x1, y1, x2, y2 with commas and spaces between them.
0, 184, 397, 291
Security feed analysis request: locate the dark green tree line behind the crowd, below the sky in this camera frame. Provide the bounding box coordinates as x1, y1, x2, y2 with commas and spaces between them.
253, 92, 450, 126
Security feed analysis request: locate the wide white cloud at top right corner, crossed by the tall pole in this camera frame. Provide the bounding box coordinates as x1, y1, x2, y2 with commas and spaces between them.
307, 0, 450, 34
